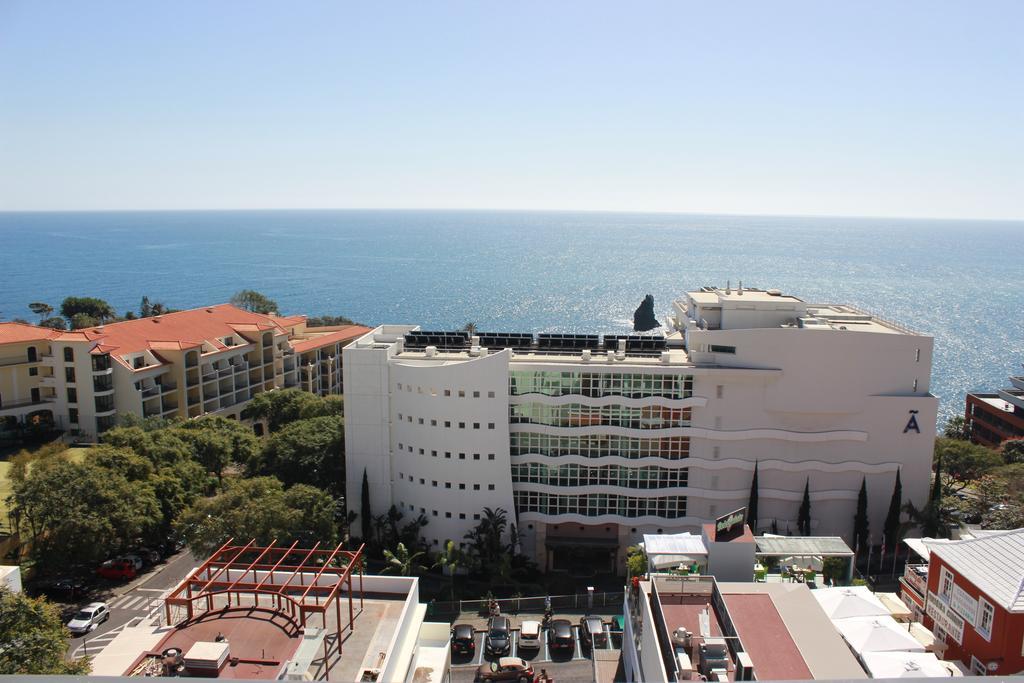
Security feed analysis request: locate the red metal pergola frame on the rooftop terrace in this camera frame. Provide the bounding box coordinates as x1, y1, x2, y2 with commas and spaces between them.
164, 539, 364, 653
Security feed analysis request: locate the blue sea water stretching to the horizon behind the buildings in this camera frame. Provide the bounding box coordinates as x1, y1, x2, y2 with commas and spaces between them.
0, 211, 1024, 417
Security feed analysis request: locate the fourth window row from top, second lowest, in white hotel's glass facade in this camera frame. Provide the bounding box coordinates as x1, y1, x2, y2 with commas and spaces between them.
512, 463, 688, 488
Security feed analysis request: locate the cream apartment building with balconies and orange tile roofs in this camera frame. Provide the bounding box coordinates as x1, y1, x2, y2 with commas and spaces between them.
0, 304, 369, 440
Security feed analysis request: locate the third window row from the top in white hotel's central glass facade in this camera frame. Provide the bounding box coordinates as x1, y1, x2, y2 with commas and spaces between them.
509, 432, 690, 460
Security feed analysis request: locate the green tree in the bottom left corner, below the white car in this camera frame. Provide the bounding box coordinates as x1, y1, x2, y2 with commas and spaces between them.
0, 584, 89, 676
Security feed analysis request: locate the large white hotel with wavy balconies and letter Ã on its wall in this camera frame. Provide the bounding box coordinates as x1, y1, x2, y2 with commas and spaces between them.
342, 287, 937, 568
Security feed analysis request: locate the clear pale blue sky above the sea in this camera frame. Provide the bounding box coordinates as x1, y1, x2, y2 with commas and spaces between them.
0, 0, 1024, 219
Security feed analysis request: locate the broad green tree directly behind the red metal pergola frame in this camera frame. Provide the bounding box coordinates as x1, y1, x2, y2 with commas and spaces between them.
176, 477, 338, 556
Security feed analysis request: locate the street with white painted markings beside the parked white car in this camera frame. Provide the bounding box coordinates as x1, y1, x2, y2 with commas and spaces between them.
68, 550, 199, 657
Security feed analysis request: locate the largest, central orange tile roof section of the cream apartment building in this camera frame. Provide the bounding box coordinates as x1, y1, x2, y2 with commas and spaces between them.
62, 303, 303, 355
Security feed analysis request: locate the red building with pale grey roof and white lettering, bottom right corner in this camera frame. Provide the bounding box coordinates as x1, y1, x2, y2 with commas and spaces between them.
924, 529, 1024, 676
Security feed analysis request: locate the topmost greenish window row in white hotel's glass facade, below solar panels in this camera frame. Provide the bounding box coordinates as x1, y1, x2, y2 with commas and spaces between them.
509, 370, 693, 398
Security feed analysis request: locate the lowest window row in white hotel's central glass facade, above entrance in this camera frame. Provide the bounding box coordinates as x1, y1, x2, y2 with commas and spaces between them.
513, 490, 686, 519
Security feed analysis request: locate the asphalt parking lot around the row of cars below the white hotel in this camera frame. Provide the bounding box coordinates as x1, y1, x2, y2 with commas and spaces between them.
452, 624, 621, 683
